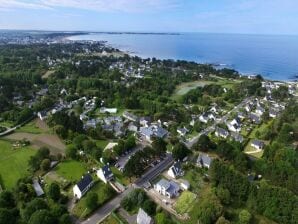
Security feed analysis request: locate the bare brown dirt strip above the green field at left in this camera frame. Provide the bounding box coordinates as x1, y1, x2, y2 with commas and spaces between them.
5, 132, 65, 155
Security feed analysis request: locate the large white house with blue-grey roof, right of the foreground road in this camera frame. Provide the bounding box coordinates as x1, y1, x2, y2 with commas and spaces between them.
154, 179, 180, 198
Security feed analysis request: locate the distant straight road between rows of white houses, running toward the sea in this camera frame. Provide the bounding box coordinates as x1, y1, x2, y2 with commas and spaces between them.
184, 98, 251, 149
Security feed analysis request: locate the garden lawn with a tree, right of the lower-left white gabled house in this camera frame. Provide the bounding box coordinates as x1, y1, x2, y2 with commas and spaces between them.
72, 181, 116, 219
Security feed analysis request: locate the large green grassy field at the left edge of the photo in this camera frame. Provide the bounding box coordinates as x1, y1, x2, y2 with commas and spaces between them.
0, 140, 36, 189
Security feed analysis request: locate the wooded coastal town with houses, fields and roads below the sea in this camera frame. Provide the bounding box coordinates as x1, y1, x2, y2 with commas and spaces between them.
0, 33, 298, 224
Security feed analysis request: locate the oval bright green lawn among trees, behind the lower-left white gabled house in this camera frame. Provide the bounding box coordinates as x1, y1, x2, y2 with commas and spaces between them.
54, 160, 87, 182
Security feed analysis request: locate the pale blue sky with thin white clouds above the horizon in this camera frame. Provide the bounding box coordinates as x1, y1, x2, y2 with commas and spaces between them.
0, 0, 298, 35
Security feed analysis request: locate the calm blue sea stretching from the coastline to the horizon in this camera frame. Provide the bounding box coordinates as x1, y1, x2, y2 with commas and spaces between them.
69, 33, 298, 80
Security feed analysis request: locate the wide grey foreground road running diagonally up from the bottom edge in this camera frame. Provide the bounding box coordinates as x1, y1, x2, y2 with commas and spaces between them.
76, 154, 173, 224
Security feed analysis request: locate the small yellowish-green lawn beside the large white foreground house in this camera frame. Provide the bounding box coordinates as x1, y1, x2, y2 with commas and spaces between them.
175, 191, 197, 214
